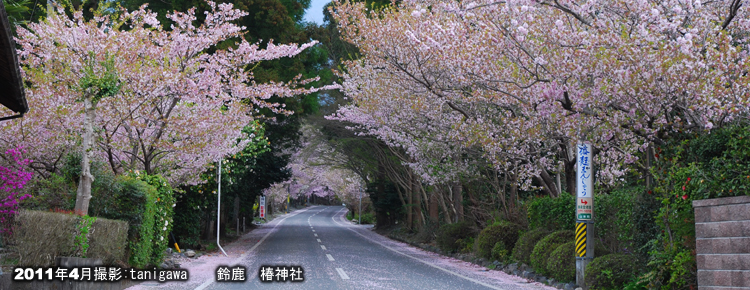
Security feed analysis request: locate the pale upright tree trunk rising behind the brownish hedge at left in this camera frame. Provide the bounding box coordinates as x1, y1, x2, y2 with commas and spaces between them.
74, 95, 96, 216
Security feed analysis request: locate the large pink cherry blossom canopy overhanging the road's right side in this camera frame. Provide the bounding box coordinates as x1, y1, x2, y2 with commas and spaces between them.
332, 0, 750, 195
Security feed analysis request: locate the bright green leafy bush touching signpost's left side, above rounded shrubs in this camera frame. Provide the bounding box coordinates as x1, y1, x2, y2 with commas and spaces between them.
528, 193, 576, 231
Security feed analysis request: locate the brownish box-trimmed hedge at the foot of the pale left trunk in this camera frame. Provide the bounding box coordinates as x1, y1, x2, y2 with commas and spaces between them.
13, 210, 128, 267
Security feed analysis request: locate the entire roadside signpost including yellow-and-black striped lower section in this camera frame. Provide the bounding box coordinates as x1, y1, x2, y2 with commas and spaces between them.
575, 142, 594, 289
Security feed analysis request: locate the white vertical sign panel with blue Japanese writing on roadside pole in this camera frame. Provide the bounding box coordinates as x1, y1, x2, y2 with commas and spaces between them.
576, 142, 594, 220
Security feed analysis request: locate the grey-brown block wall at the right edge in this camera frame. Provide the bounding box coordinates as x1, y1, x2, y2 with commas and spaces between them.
693, 196, 750, 290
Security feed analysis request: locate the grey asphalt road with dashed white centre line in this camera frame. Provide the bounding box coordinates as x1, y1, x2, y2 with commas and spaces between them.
191, 206, 554, 290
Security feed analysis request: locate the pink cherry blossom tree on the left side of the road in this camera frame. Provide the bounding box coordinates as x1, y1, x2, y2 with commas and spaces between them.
0, 1, 336, 214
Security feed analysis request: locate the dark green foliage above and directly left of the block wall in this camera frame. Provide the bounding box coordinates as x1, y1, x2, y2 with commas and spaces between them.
649, 121, 750, 289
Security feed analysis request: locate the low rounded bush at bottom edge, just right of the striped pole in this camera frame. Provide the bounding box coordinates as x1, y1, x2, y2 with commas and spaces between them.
586, 254, 639, 290
